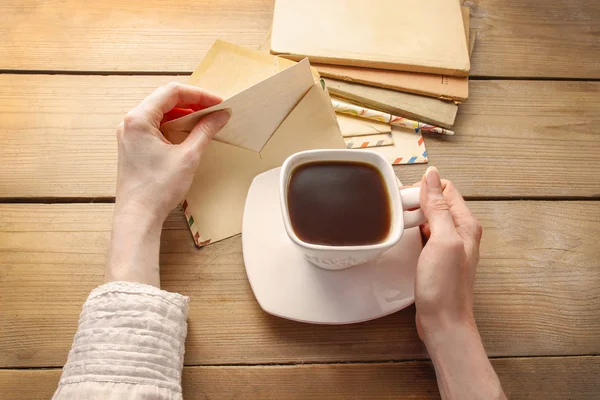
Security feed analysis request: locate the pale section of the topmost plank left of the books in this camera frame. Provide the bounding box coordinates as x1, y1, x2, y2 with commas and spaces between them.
0, 0, 273, 73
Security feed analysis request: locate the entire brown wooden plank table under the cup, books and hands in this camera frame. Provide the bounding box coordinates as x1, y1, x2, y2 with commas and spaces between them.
0, 0, 600, 400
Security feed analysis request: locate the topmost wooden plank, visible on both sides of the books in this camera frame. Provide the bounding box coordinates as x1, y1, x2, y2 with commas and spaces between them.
0, 0, 600, 78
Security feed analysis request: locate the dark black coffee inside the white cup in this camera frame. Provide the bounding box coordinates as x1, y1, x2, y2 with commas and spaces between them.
287, 161, 392, 246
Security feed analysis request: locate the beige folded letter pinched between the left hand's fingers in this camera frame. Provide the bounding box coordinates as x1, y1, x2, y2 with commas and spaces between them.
161, 59, 314, 151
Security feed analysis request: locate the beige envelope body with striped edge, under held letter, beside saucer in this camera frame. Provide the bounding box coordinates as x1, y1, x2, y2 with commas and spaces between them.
184, 84, 344, 246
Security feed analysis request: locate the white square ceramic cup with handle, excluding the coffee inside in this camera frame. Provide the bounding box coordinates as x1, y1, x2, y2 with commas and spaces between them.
279, 150, 425, 270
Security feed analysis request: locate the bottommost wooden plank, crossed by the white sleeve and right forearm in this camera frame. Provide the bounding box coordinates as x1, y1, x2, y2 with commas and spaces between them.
0, 356, 600, 400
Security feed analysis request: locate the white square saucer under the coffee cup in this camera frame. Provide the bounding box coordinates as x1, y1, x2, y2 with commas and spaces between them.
242, 168, 422, 324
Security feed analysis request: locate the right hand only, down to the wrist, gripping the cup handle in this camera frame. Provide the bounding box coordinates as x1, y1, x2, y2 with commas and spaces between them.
415, 167, 482, 344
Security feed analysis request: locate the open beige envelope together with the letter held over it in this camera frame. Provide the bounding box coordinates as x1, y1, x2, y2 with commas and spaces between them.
161, 41, 345, 246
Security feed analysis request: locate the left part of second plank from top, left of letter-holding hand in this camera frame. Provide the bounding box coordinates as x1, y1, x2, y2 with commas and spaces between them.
0, 75, 188, 197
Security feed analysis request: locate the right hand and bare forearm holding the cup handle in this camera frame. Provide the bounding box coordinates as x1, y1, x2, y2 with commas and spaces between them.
415, 167, 506, 400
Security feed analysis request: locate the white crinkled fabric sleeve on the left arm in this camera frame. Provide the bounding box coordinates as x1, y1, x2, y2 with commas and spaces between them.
53, 282, 189, 400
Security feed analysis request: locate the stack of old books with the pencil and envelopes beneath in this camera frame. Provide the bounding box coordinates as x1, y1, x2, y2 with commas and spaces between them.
271, 0, 472, 164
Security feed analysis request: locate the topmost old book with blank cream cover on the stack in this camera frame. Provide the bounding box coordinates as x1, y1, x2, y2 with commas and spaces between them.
271, 0, 470, 76
